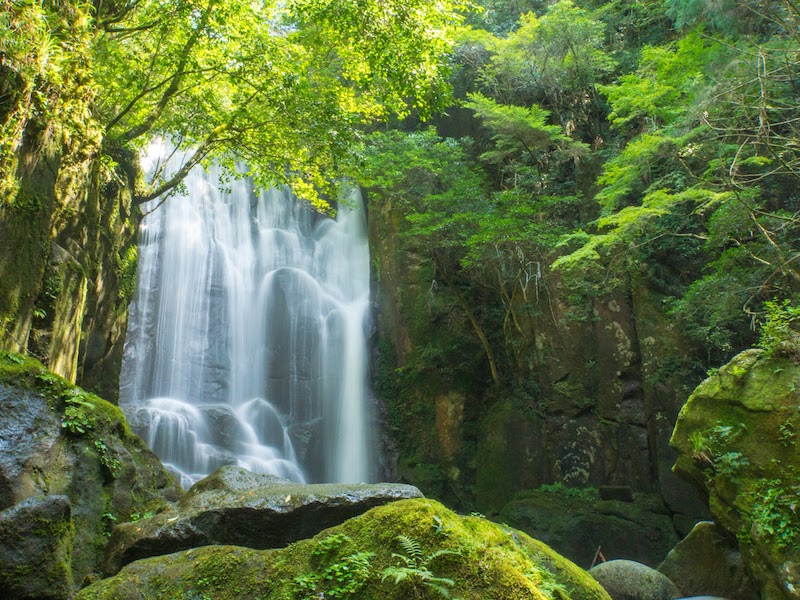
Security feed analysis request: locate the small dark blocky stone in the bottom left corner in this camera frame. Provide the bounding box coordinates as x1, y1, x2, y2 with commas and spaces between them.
0, 496, 74, 600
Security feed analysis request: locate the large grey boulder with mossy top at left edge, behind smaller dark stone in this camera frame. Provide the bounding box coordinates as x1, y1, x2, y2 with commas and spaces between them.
0, 353, 182, 597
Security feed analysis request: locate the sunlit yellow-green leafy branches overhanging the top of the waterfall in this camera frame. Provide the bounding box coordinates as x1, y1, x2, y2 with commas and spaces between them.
94, 0, 466, 209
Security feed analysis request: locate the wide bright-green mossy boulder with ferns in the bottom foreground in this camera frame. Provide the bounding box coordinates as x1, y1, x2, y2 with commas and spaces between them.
78, 499, 608, 600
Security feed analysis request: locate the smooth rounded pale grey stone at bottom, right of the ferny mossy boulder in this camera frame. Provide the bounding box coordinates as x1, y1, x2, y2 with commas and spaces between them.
589, 560, 682, 600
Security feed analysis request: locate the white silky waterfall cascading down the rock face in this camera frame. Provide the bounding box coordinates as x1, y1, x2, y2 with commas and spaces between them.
121, 148, 374, 487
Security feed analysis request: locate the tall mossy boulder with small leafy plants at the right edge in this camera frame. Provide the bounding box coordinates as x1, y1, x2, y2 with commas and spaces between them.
671, 350, 800, 599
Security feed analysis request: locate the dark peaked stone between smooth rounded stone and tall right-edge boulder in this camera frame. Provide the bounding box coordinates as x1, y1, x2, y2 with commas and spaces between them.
658, 521, 758, 600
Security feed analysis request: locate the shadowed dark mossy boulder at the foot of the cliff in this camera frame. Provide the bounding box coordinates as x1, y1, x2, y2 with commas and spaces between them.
499, 485, 678, 568
